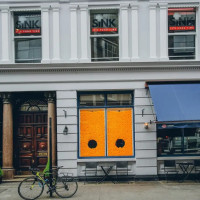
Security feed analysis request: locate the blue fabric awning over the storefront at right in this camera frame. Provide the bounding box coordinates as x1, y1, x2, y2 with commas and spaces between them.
149, 83, 200, 128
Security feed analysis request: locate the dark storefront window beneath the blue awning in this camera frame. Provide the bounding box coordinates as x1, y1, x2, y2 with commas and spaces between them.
157, 128, 200, 156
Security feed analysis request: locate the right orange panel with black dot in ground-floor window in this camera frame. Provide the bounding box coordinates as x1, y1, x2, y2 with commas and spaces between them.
107, 108, 133, 156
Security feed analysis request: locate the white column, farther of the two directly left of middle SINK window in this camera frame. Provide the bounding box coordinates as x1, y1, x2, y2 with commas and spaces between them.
70, 5, 78, 62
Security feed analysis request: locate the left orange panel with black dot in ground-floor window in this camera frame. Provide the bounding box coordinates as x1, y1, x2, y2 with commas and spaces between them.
80, 109, 105, 157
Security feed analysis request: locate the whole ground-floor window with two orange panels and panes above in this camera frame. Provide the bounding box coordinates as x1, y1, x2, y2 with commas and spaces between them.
79, 93, 134, 158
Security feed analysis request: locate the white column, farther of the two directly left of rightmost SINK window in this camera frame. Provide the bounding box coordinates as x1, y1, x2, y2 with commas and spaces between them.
149, 3, 157, 59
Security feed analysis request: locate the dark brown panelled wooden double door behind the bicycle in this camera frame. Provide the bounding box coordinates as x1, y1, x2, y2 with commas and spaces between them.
16, 112, 48, 171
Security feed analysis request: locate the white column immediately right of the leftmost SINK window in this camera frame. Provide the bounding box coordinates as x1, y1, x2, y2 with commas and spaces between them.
41, 7, 50, 63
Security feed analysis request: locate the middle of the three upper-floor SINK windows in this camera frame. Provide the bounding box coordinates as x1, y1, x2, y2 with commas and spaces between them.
90, 9, 119, 61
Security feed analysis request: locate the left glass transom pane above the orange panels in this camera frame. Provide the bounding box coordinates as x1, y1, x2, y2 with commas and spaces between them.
80, 94, 104, 106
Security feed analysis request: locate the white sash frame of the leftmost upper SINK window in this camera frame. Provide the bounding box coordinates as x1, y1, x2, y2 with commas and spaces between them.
11, 9, 43, 64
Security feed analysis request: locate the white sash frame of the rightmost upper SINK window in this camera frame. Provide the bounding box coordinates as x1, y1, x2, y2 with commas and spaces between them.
167, 5, 198, 61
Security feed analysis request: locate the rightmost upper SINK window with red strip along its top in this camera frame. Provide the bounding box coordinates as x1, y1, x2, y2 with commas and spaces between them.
168, 8, 196, 60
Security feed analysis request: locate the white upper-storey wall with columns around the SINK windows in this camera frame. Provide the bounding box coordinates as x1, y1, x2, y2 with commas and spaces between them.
0, 0, 199, 63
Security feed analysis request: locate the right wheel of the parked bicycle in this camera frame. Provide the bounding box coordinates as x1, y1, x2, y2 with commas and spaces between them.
55, 177, 78, 198
